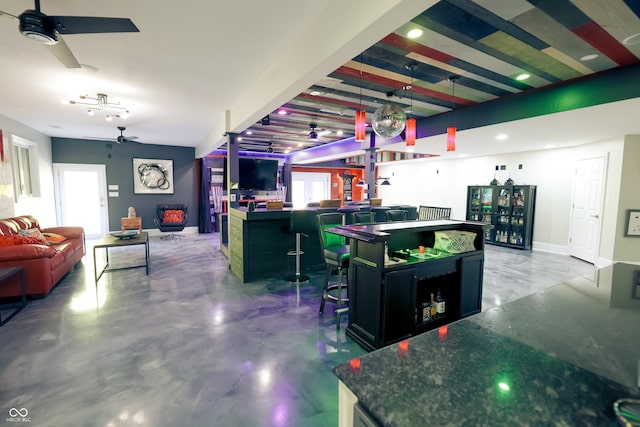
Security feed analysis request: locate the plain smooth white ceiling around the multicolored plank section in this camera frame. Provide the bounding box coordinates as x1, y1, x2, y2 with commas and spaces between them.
0, 0, 640, 161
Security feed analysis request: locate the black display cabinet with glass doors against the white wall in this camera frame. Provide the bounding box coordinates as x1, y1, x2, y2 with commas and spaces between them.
467, 185, 536, 249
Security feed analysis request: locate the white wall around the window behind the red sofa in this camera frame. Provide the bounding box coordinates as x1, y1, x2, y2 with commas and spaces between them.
0, 114, 56, 227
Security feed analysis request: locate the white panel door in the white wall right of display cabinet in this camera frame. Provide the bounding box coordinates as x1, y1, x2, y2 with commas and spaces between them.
569, 156, 607, 264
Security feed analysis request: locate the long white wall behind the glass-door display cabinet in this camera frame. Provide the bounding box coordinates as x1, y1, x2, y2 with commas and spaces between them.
378, 138, 624, 260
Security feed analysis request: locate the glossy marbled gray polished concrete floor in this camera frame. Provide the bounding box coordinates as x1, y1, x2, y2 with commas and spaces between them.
0, 234, 593, 427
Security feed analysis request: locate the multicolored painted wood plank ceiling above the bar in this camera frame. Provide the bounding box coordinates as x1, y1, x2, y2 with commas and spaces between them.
235, 0, 640, 152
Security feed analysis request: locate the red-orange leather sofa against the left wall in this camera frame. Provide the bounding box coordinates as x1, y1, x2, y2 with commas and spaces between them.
0, 215, 85, 298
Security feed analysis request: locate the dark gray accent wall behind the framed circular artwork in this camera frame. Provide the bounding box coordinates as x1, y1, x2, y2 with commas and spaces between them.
51, 138, 198, 230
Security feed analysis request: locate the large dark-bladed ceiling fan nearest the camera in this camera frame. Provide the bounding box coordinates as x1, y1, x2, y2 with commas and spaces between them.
0, 0, 140, 68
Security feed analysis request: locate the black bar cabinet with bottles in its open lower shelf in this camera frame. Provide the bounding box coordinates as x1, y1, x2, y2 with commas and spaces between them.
332, 221, 484, 350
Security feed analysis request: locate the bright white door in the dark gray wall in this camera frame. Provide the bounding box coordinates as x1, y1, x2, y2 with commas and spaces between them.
53, 163, 109, 239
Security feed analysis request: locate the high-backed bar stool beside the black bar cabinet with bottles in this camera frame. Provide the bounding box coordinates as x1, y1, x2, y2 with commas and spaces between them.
316, 212, 349, 328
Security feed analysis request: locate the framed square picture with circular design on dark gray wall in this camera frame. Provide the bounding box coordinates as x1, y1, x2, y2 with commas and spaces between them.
133, 159, 173, 194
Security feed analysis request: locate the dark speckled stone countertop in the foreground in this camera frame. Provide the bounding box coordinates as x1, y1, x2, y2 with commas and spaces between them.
334, 270, 640, 426
